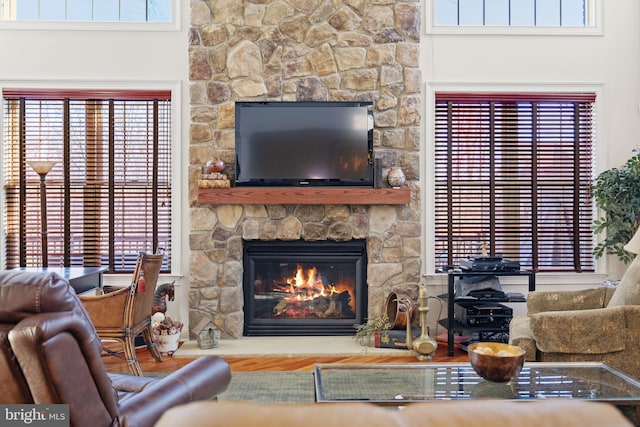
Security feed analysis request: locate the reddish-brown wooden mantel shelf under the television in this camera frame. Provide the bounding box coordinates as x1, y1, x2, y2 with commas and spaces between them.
198, 187, 411, 205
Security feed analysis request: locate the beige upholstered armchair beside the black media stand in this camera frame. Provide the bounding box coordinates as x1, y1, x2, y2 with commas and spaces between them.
509, 231, 640, 378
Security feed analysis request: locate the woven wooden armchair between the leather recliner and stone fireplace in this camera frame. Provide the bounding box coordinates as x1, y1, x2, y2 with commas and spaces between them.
80, 252, 164, 376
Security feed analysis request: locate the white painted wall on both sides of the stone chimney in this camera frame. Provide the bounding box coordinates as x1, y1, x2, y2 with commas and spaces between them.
0, 0, 640, 326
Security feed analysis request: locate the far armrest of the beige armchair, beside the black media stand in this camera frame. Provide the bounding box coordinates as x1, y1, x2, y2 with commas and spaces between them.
527, 286, 608, 316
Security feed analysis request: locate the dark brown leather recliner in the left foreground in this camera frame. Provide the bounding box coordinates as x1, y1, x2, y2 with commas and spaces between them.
0, 270, 231, 427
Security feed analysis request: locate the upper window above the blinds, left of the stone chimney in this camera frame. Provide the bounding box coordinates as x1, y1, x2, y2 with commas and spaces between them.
0, 0, 173, 22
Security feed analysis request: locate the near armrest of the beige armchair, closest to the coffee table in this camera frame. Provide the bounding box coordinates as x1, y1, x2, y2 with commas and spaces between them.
529, 307, 626, 354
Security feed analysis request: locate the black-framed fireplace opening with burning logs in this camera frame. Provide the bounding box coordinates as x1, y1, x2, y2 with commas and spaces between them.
243, 240, 367, 336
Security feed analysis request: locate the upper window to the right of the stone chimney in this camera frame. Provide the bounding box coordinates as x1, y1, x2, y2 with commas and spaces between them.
433, 0, 591, 27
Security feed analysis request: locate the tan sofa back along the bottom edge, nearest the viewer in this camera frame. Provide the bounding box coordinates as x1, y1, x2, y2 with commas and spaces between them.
156, 399, 633, 427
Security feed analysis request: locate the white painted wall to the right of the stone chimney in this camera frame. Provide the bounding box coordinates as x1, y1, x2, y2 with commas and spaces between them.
421, 0, 640, 283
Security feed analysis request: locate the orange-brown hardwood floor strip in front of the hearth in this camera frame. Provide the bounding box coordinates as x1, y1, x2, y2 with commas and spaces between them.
103, 345, 469, 373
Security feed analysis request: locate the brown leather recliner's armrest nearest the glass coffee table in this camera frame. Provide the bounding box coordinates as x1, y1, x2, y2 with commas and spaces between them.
120, 356, 231, 426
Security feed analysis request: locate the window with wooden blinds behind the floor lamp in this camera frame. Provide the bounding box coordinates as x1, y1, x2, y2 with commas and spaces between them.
3, 90, 171, 273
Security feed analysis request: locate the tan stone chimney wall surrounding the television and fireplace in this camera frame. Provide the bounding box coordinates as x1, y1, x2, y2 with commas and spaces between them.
188, 0, 422, 338
